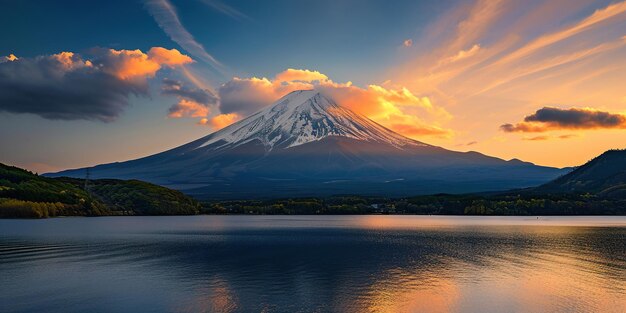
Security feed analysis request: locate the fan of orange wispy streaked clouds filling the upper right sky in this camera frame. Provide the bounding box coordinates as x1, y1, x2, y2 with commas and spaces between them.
394, 0, 626, 150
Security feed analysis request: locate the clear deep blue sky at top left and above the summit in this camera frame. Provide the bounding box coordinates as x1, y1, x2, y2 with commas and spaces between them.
0, 0, 452, 83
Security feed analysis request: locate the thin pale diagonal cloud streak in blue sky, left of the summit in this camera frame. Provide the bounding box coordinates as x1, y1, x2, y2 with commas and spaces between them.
144, 0, 224, 72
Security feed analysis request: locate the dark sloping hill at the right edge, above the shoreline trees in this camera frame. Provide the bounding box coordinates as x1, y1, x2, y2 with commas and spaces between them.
536, 150, 626, 198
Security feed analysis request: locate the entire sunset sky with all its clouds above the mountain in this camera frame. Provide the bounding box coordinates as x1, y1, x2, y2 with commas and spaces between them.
0, 0, 626, 173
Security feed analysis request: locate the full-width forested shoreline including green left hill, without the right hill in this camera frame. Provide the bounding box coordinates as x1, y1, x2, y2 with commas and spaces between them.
0, 164, 626, 218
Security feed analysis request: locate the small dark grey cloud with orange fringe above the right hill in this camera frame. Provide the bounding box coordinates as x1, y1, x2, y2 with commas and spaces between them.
500, 107, 626, 132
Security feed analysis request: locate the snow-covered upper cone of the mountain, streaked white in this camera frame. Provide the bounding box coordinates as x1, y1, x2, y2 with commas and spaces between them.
198, 90, 426, 150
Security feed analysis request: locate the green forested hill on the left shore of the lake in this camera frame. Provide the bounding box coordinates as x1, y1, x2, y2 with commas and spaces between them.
0, 163, 200, 218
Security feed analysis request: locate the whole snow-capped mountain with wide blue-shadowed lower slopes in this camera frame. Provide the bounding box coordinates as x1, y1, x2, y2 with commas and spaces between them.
48, 90, 565, 199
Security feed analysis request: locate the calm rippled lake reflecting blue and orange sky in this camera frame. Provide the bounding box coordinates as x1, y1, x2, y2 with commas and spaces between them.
0, 216, 626, 312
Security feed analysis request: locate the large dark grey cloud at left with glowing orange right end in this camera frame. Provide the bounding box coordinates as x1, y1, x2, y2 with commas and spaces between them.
0, 47, 192, 122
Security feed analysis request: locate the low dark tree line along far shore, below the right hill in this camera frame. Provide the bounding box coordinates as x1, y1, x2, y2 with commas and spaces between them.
202, 194, 626, 215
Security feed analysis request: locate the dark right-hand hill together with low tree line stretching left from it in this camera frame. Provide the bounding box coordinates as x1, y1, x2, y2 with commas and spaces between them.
206, 150, 626, 216
